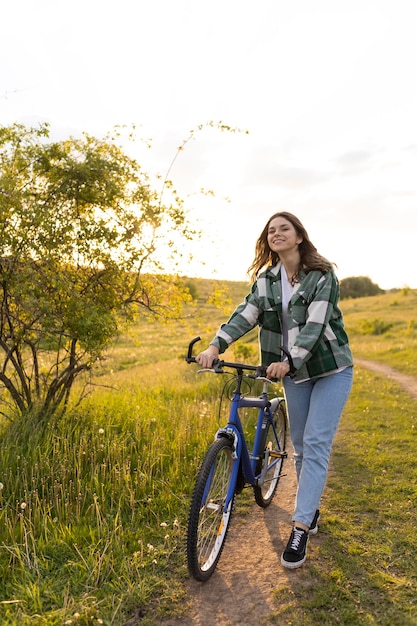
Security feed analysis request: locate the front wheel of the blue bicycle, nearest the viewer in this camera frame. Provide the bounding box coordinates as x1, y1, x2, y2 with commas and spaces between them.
187, 437, 236, 582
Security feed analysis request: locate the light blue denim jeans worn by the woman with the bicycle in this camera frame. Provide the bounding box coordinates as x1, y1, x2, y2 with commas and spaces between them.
283, 367, 353, 526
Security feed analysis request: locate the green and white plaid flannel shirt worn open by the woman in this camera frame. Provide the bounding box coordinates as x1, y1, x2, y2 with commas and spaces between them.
211, 263, 353, 381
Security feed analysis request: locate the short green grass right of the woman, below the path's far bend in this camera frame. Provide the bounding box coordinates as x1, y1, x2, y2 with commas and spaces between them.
266, 369, 417, 626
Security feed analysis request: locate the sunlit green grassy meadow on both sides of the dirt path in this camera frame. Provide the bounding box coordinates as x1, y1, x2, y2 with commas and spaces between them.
0, 281, 417, 626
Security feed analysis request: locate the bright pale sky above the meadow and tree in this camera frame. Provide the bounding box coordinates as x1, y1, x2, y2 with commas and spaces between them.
0, 0, 417, 289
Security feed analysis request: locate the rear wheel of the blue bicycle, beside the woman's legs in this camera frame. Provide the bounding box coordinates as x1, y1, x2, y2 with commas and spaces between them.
253, 402, 287, 508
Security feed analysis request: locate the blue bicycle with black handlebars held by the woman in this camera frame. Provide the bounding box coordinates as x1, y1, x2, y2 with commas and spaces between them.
186, 337, 294, 582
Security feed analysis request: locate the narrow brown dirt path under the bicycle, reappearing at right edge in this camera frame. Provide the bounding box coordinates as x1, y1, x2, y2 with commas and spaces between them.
160, 359, 417, 626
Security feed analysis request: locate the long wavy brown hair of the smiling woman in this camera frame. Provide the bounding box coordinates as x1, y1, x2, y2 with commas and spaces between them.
248, 211, 333, 282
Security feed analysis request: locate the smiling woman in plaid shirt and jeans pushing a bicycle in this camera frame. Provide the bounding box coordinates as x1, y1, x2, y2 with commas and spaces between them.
196, 212, 353, 569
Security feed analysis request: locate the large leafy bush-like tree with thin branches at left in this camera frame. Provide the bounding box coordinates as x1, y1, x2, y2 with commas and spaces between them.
0, 124, 196, 419
